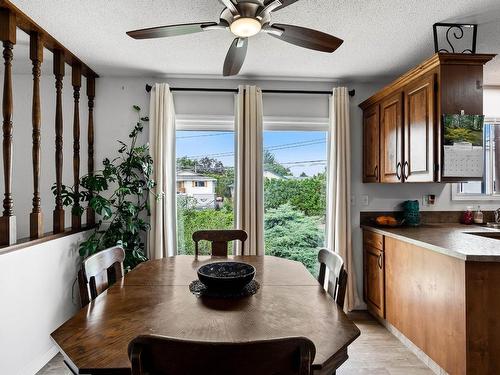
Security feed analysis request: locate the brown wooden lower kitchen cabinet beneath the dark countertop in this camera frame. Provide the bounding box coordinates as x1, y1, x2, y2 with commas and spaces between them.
363, 228, 500, 375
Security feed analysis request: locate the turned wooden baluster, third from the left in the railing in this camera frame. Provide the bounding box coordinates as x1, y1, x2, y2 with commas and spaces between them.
54, 50, 64, 233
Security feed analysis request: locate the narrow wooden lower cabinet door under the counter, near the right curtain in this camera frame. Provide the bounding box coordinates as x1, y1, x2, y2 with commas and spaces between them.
364, 246, 385, 319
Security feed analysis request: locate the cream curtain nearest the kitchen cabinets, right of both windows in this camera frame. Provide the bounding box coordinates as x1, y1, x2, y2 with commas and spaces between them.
326, 87, 359, 310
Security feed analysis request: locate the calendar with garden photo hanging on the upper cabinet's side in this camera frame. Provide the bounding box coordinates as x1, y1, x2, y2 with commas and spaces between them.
442, 114, 484, 179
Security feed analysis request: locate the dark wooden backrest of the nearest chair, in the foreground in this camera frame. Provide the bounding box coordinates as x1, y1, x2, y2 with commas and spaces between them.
128, 335, 316, 375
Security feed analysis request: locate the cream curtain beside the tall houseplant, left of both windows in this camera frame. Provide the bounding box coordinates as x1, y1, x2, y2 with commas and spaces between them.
148, 83, 177, 259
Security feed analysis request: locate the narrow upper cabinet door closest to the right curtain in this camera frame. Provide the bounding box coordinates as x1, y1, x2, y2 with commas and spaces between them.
363, 104, 380, 182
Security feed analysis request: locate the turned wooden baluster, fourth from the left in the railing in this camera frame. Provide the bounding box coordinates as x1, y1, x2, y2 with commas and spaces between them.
71, 64, 82, 230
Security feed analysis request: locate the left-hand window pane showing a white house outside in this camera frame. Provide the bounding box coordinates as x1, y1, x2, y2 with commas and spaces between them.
176, 118, 234, 254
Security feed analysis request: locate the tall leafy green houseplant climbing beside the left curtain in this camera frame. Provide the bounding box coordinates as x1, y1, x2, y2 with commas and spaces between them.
52, 106, 155, 270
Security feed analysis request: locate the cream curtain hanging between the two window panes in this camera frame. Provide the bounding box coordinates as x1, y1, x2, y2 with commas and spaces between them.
235, 86, 264, 255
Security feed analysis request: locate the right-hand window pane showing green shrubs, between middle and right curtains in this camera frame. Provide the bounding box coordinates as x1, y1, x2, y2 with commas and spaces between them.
264, 119, 328, 274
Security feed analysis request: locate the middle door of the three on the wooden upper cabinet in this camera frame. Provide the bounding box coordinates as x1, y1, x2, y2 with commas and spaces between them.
380, 92, 403, 182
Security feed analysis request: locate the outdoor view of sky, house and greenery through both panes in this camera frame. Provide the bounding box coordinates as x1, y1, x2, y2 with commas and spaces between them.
176, 131, 327, 274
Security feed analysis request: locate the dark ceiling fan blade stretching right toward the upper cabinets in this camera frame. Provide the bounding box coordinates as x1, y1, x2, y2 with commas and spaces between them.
269, 23, 344, 53
